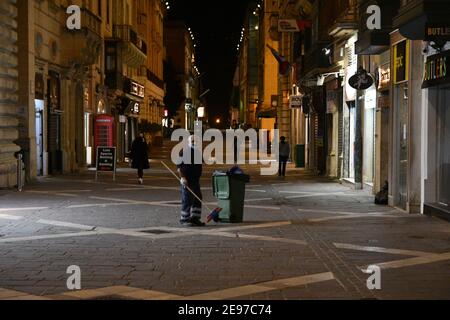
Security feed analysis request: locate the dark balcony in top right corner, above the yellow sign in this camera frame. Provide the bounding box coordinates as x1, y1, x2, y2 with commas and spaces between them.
394, 0, 450, 41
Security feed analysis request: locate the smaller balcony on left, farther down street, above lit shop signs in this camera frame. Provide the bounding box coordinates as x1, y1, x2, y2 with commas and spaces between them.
113, 25, 147, 68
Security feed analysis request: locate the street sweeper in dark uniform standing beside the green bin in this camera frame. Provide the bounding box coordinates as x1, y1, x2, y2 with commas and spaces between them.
177, 136, 205, 227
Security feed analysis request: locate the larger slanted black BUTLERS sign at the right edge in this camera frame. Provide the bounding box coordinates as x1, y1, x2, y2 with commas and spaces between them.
422, 50, 450, 88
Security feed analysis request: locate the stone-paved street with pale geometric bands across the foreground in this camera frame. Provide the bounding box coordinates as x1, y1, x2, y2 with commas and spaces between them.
0, 149, 450, 299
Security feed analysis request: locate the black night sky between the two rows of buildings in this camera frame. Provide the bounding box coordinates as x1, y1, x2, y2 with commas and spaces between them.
168, 0, 250, 125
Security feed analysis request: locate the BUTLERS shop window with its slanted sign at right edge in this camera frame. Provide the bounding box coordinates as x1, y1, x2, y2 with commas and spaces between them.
423, 46, 450, 220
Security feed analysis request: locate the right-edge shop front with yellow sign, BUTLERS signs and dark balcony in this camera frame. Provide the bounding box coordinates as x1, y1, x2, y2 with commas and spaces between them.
390, 0, 450, 216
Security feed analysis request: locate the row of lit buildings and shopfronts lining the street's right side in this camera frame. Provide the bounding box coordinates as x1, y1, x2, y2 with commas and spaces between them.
233, 0, 450, 220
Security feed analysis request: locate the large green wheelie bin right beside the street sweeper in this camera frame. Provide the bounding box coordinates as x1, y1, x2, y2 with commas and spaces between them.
213, 172, 250, 223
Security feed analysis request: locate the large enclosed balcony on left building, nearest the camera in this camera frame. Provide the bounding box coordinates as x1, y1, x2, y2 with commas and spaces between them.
61, 8, 102, 71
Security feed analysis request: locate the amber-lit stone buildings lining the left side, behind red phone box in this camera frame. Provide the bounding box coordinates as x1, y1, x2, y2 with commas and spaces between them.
6, 0, 165, 185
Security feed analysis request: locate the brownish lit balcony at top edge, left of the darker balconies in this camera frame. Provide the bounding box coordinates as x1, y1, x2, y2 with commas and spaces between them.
328, 0, 358, 38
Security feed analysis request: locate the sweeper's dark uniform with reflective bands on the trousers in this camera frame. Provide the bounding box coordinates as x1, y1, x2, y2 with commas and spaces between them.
178, 147, 203, 223
